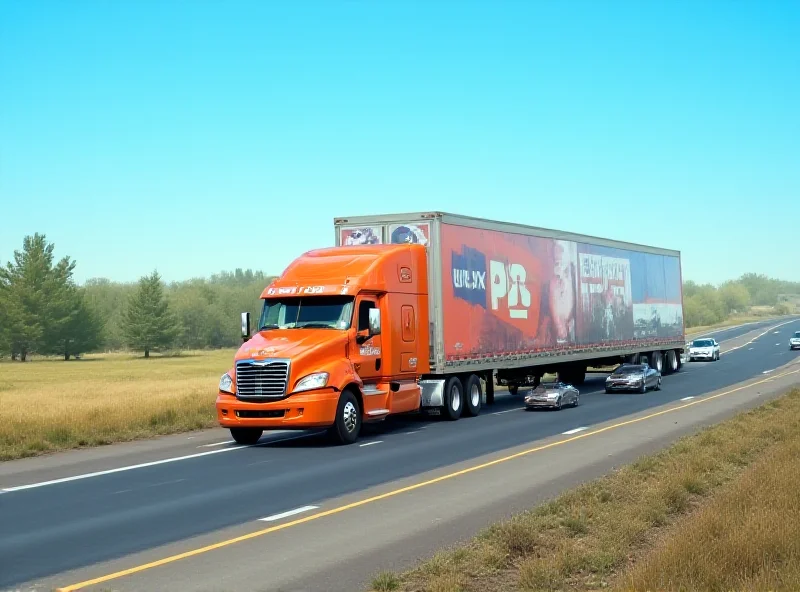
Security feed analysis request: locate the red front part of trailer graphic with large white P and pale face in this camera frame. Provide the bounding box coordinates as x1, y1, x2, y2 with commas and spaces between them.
441, 225, 577, 359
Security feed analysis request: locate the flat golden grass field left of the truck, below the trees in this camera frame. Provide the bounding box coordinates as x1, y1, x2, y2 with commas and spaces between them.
0, 350, 234, 460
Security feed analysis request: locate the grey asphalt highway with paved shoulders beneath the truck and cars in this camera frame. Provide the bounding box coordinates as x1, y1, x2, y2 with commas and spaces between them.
0, 319, 800, 591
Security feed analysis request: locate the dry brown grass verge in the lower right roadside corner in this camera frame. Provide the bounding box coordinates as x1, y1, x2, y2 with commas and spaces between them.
372, 389, 800, 592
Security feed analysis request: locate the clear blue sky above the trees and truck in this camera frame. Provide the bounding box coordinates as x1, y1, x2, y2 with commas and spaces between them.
0, 0, 800, 283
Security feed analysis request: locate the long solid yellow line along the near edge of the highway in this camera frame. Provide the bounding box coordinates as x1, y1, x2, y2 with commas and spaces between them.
56, 369, 800, 592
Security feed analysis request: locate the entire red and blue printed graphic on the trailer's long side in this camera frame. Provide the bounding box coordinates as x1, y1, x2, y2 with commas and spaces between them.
442, 225, 683, 360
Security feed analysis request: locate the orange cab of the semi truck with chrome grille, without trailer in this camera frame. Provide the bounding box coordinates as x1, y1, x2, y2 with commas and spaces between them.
216, 244, 429, 444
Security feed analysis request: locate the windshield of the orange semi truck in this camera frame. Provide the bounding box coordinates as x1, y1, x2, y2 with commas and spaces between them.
258, 296, 353, 331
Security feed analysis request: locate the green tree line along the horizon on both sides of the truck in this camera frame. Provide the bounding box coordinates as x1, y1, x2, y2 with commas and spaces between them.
0, 234, 800, 361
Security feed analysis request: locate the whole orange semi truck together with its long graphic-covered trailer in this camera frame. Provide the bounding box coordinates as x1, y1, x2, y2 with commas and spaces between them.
216, 212, 685, 444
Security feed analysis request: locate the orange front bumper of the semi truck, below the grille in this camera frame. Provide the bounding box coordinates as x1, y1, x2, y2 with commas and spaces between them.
216, 389, 339, 430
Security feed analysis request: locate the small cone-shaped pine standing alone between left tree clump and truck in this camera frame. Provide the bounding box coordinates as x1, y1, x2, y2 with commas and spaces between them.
123, 271, 179, 358
